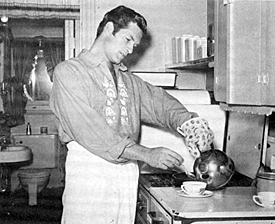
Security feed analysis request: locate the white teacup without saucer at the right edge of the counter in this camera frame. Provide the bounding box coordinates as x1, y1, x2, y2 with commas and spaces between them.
253, 191, 275, 208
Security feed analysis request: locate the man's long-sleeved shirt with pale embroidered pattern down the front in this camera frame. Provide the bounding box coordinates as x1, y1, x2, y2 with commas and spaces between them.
50, 50, 191, 163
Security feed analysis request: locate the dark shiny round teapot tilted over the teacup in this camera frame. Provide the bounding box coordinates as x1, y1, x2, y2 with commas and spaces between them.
193, 149, 235, 190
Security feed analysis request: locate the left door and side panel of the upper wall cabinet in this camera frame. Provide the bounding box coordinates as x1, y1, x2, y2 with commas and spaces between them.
214, 0, 262, 105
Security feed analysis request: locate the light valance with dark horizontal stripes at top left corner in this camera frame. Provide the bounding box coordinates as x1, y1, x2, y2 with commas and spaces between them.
0, 0, 80, 19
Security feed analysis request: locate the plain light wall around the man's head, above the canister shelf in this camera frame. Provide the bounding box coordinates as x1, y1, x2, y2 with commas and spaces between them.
82, 0, 207, 71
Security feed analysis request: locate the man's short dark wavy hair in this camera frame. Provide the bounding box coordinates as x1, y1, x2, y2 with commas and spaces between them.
96, 5, 147, 38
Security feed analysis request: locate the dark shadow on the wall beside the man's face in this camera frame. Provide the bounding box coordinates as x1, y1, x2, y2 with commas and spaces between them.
123, 32, 152, 69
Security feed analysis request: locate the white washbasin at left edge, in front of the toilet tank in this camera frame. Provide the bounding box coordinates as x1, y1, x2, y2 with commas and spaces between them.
0, 145, 32, 163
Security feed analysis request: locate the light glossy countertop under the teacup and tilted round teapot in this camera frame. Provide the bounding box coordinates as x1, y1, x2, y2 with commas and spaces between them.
150, 187, 275, 220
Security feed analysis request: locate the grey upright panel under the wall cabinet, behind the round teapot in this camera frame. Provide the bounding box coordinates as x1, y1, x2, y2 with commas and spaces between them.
226, 112, 265, 178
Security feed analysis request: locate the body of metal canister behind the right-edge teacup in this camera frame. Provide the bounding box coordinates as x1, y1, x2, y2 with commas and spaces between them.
256, 172, 275, 192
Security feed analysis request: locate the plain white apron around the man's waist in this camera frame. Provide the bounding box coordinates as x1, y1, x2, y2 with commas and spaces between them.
61, 141, 139, 224
